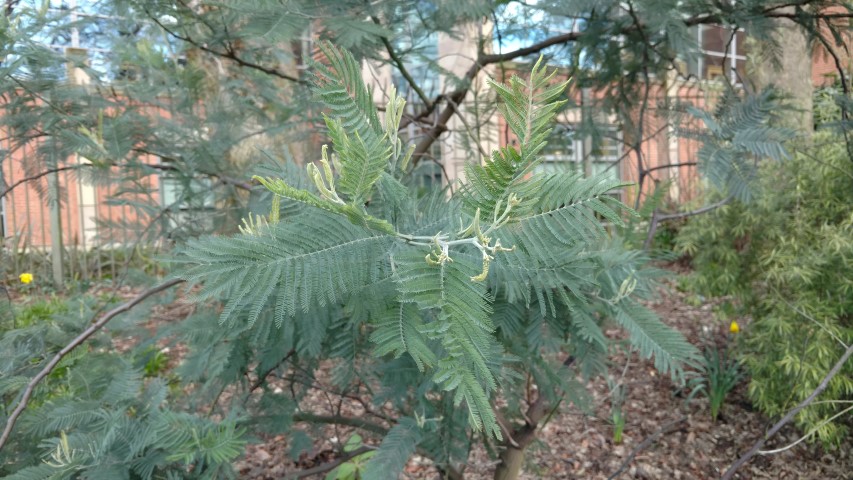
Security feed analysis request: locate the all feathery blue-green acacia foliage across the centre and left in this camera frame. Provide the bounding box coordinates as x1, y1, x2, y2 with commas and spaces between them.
5, 0, 835, 478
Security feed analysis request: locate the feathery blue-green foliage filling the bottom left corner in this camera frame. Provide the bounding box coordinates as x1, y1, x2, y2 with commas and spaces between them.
0, 290, 245, 480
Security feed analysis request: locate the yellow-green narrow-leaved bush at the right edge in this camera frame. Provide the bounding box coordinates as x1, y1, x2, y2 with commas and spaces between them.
677, 133, 853, 445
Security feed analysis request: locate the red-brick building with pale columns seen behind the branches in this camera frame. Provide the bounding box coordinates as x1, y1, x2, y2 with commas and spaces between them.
0, 17, 849, 248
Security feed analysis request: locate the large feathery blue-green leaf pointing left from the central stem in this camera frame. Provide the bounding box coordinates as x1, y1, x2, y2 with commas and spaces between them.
176, 211, 391, 325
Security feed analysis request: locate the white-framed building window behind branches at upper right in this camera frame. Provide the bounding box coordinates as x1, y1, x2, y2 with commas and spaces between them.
687, 25, 746, 84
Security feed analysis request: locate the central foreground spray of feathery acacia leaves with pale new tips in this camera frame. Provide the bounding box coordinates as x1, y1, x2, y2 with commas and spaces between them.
176, 44, 695, 478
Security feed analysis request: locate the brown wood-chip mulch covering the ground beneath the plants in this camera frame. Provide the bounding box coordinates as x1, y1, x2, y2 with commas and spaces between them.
235, 272, 853, 480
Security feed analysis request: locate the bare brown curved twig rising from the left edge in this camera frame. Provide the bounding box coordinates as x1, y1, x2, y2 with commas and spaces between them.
0, 279, 184, 450
